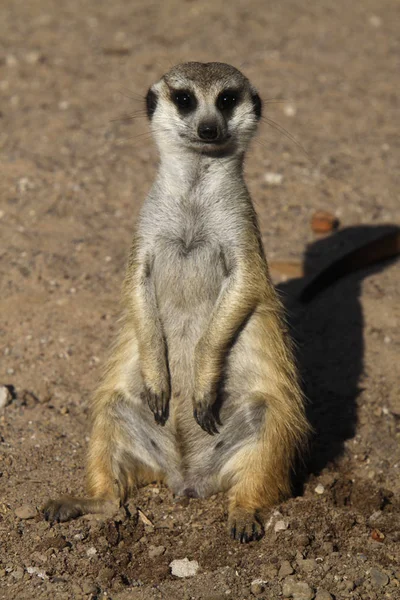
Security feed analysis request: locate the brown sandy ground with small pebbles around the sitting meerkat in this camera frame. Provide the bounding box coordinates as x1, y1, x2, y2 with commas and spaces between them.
0, 0, 400, 600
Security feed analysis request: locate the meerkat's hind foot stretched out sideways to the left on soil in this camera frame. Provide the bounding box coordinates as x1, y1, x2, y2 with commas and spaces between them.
42, 496, 115, 523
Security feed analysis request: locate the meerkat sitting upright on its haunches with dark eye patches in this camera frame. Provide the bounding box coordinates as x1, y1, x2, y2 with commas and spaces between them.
44, 62, 309, 542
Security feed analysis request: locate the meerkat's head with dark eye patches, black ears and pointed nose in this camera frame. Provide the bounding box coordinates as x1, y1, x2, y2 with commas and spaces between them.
146, 62, 261, 156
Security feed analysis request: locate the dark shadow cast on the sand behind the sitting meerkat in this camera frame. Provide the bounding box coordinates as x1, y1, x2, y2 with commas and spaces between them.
277, 225, 400, 480
